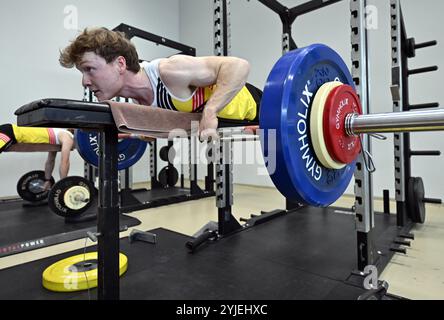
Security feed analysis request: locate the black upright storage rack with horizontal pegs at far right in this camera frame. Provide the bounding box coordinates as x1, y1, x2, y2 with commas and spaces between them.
390, 0, 441, 231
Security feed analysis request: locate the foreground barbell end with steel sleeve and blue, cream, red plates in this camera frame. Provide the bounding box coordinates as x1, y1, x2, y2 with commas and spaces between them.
259, 44, 444, 207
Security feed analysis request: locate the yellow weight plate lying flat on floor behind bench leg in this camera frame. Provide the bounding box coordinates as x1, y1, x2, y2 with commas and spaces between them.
42, 252, 128, 292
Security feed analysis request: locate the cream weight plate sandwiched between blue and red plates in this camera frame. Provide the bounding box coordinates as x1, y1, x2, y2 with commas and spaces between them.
310, 81, 346, 170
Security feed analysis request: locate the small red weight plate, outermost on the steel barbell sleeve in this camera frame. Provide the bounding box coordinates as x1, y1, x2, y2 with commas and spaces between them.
323, 84, 362, 163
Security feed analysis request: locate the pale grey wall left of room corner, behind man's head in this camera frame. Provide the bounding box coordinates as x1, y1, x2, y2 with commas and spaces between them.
0, 0, 179, 196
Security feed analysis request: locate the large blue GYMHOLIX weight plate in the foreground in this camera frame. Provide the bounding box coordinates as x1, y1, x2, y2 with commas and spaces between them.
260, 44, 355, 207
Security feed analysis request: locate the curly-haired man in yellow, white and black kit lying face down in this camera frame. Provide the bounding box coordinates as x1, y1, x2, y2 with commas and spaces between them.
59, 28, 262, 140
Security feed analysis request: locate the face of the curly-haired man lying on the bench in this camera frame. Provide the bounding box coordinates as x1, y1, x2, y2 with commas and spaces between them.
76, 52, 122, 101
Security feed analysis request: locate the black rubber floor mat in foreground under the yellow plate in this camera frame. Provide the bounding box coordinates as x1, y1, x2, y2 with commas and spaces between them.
0, 208, 395, 300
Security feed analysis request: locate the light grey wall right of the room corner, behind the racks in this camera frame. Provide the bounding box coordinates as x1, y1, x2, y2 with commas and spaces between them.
180, 0, 444, 198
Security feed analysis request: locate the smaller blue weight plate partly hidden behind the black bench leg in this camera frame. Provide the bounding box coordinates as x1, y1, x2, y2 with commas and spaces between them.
75, 130, 147, 170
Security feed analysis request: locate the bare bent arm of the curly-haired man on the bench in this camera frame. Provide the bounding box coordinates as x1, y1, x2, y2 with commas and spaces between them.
159, 55, 250, 138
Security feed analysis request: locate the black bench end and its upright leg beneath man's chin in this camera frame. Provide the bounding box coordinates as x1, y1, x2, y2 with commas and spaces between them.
15, 99, 120, 300
